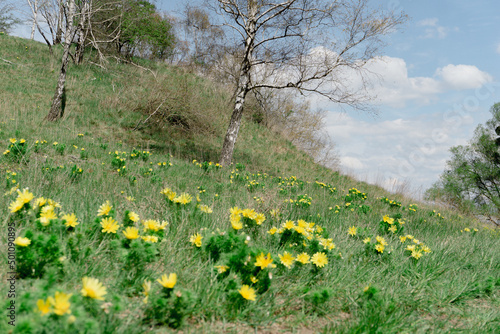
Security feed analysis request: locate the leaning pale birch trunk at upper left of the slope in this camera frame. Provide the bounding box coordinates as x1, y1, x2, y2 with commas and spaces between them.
47, 0, 75, 122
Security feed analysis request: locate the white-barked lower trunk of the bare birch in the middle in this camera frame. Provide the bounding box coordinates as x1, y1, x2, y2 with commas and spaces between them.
219, 76, 248, 166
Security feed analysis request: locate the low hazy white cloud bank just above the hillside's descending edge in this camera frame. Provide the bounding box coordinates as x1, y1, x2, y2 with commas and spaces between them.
325, 111, 476, 190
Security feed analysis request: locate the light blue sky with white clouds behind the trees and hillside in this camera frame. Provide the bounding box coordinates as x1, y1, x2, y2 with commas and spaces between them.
10, 0, 500, 197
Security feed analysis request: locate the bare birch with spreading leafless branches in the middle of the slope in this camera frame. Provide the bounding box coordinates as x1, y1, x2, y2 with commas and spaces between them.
211, 0, 406, 165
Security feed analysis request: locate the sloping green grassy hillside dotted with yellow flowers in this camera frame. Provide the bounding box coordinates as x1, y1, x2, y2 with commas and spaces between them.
0, 35, 500, 333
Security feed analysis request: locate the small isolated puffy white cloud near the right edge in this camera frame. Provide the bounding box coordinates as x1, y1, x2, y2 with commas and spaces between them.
436, 64, 493, 90
